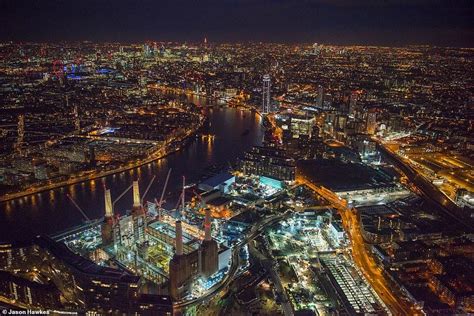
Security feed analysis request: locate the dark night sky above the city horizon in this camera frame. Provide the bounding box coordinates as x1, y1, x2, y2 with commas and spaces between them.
0, 0, 474, 47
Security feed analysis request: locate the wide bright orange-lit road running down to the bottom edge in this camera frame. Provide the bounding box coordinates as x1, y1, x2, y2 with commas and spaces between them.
297, 176, 416, 315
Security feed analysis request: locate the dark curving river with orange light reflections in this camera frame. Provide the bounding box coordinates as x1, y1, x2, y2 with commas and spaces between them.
0, 98, 263, 242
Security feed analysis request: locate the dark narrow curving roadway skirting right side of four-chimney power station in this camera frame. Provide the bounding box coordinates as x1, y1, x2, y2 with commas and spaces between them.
173, 211, 291, 309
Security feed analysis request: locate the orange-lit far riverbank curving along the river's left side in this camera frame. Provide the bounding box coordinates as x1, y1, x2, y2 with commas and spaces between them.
0, 118, 205, 203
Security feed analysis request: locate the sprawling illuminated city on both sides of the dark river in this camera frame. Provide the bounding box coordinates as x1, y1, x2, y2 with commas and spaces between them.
0, 39, 474, 316
